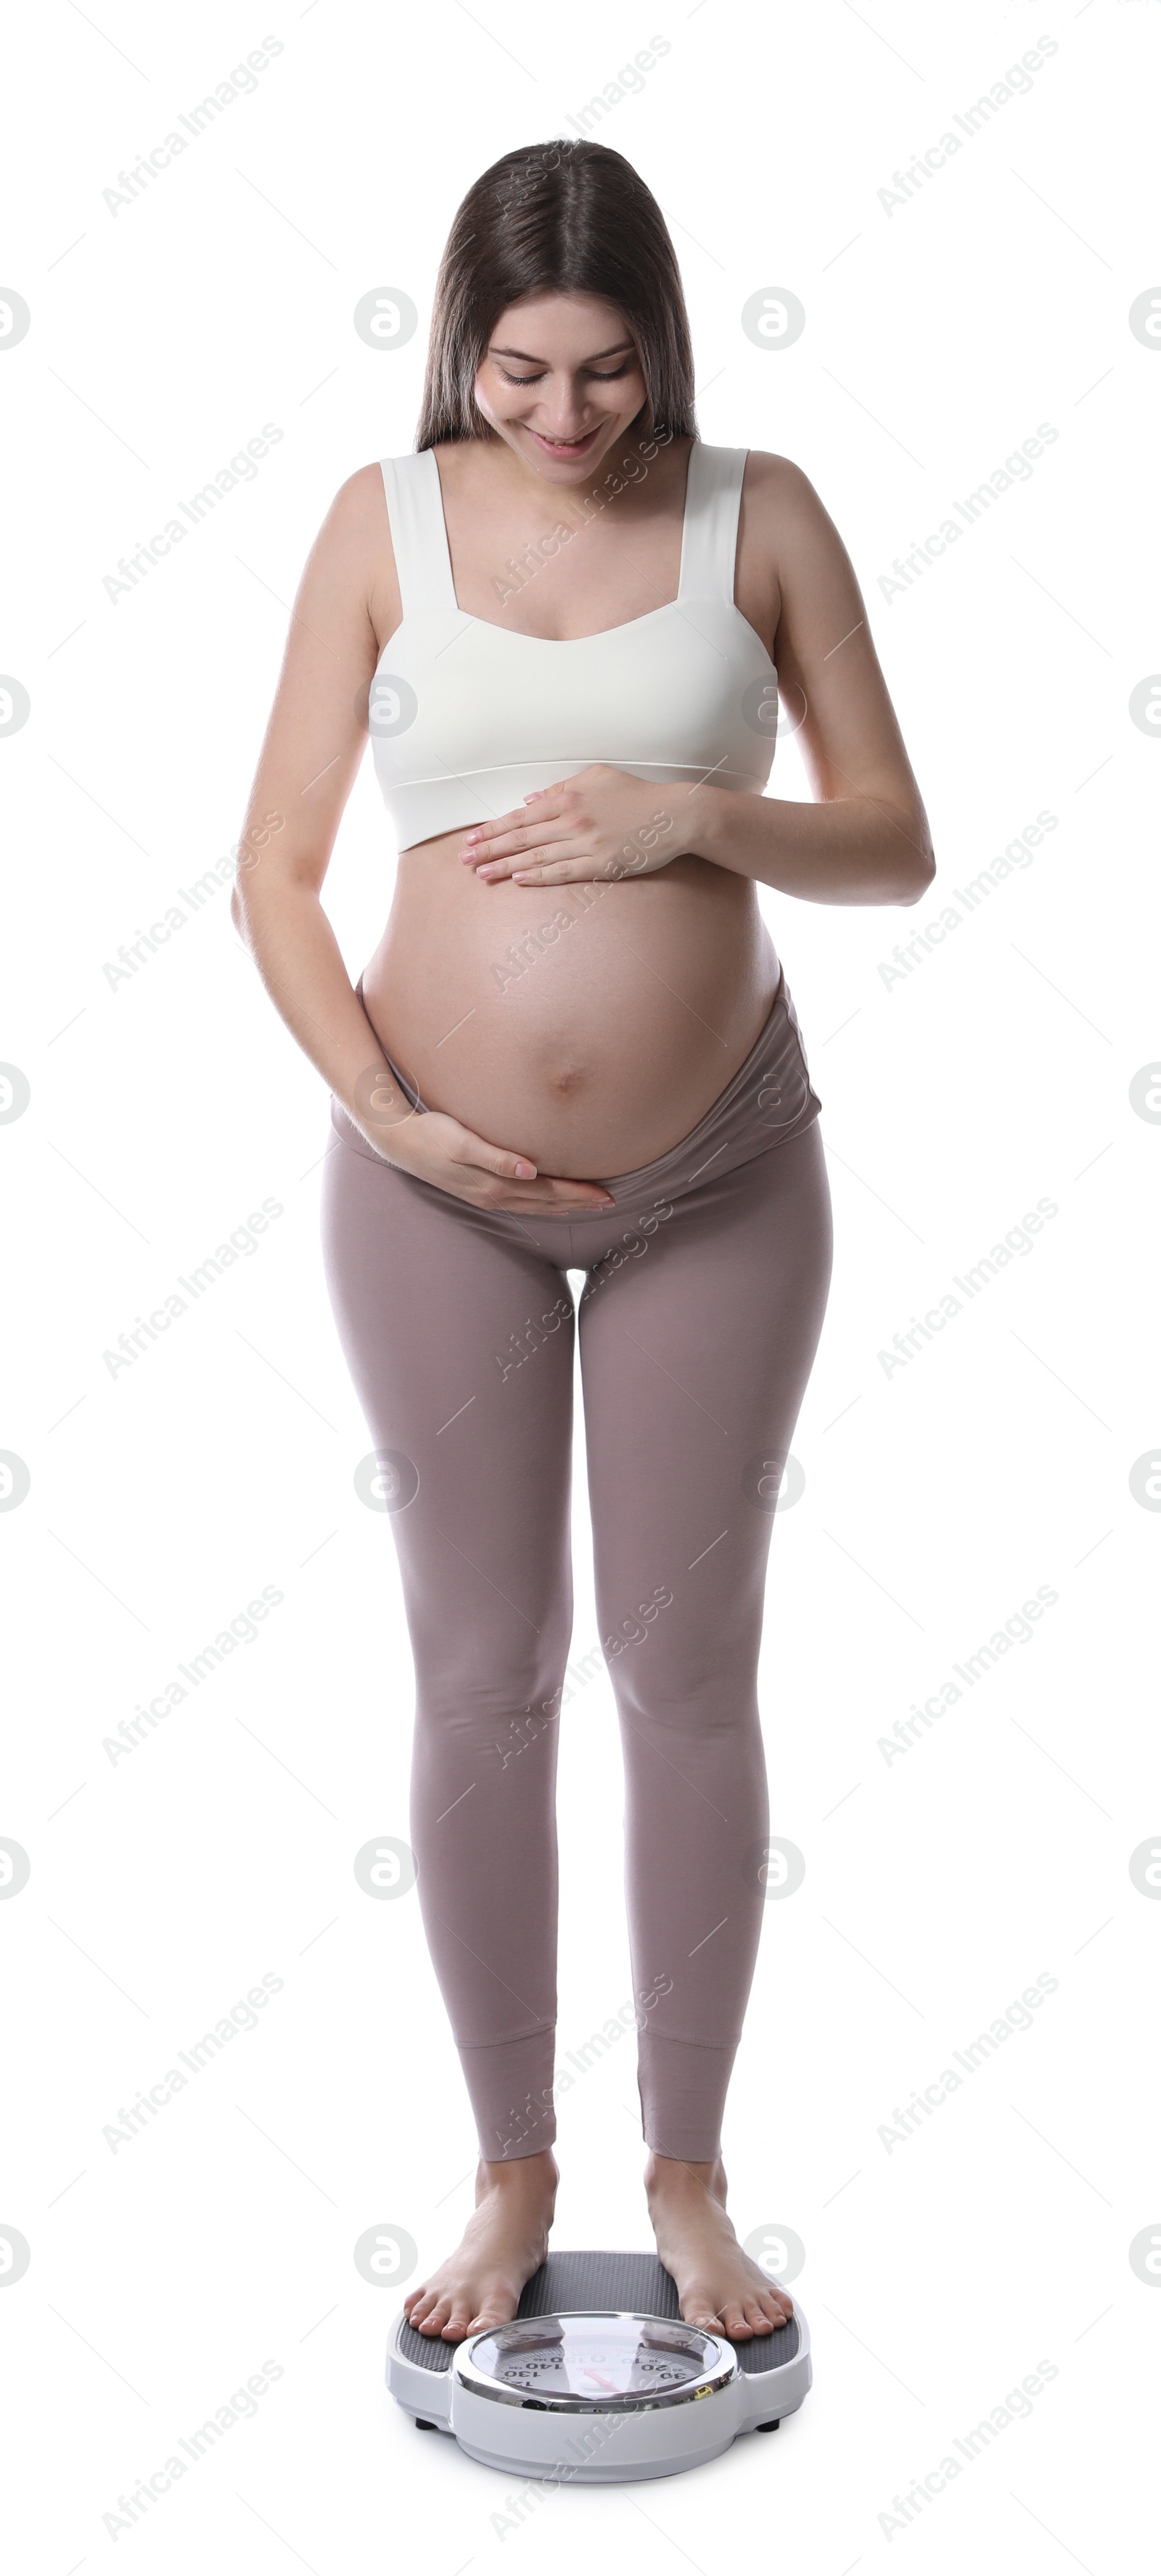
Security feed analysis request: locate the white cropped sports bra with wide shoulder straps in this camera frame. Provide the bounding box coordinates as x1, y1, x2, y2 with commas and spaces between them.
368, 438, 777, 850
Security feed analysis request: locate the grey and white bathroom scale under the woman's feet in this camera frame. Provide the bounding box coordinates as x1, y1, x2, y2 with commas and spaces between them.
386, 2254, 811, 2486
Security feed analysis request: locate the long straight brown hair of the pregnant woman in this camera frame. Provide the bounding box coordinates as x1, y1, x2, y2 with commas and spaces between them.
414, 136, 697, 450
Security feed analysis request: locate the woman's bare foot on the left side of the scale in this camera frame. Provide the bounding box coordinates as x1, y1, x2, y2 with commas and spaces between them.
404, 2149, 561, 2344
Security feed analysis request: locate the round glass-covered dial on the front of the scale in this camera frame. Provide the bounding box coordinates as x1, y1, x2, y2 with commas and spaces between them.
456, 2308, 739, 2414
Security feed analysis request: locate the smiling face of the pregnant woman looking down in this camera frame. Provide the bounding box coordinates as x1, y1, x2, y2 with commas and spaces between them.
476, 294, 646, 485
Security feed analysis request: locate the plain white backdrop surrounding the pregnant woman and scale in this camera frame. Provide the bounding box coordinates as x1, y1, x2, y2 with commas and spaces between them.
0, 0, 1161, 2576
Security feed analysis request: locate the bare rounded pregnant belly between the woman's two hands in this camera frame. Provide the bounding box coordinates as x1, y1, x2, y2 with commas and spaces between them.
363, 832, 777, 1180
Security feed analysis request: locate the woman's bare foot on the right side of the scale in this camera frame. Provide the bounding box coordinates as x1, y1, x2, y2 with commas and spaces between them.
646, 2154, 793, 2344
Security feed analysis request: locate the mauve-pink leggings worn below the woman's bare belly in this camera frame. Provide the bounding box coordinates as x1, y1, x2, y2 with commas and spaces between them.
321, 982, 832, 2161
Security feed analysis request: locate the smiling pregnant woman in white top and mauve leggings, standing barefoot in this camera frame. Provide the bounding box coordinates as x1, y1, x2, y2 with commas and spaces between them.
234, 141, 935, 2342
